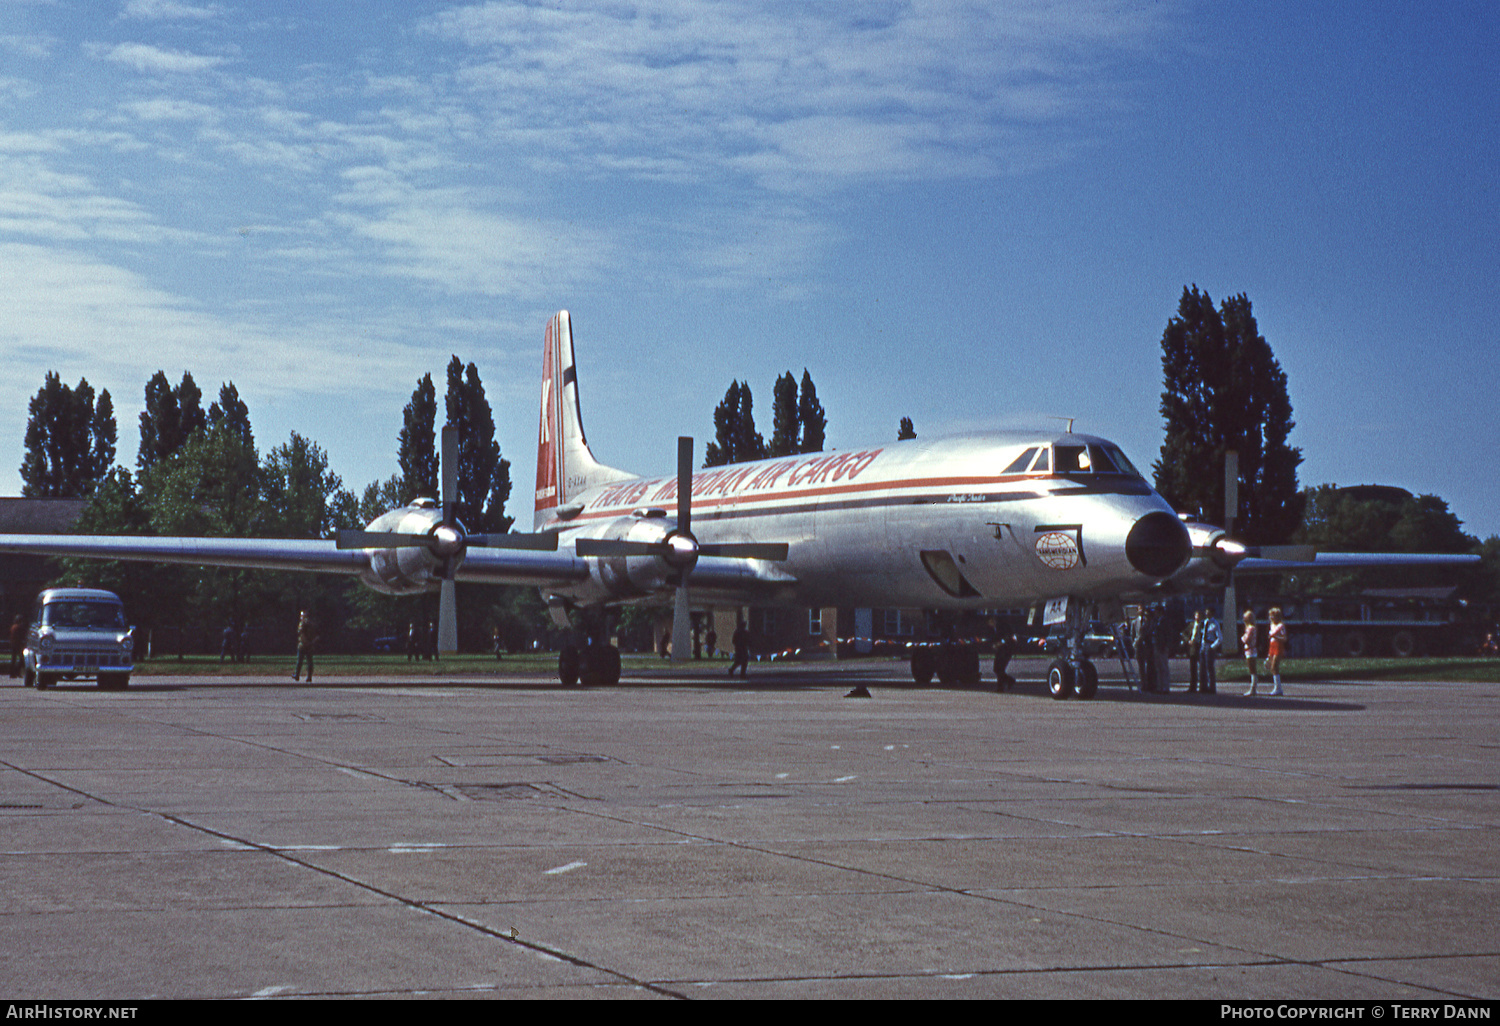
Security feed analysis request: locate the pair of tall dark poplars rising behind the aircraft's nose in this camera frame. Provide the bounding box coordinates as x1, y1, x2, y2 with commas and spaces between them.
1154, 285, 1304, 545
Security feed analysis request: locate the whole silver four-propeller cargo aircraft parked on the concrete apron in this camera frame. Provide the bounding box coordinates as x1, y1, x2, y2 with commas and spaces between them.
0, 311, 1476, 698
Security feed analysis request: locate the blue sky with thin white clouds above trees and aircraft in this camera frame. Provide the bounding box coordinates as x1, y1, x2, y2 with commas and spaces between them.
0, 0, 1500, 536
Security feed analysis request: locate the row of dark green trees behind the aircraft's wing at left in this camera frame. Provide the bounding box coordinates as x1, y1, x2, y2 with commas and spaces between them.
21, 357, 528, 645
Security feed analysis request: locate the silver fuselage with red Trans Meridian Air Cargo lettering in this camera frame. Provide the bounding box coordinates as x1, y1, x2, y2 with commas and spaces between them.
536, 432, 1188, 609
